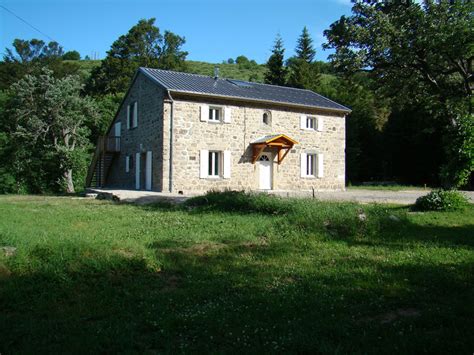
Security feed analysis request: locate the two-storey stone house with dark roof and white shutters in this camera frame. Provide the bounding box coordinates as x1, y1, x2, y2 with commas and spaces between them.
87, 68, 350, 194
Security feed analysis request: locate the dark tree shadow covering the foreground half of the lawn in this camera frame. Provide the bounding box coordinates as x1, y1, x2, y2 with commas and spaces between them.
0, 234, 474, 353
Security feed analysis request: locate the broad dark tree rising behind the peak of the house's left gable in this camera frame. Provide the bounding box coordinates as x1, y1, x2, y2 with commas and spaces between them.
87, 18, 188, 94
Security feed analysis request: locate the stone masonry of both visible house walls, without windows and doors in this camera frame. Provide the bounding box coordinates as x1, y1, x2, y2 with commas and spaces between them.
107, 74, 345, 194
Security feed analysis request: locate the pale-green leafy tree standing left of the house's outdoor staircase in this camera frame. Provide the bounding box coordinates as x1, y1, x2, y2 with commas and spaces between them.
9, 68, 97, 193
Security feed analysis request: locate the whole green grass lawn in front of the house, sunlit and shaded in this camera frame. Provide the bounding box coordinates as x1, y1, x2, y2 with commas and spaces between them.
0, 193, 474, 354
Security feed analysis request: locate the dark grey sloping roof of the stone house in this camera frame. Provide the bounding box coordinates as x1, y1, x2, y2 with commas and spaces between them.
140, 68, 350, 112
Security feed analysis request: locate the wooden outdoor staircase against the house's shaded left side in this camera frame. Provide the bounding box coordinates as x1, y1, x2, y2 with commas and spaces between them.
86, 136, 120, 188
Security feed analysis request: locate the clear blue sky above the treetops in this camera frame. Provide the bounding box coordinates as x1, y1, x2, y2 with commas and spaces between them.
0, 0, 351, 63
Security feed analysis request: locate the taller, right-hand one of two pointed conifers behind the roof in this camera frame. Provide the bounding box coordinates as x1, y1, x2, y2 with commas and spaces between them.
287, 27, 321, 91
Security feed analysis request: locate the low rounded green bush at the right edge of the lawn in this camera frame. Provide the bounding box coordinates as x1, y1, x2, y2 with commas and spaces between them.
414, 190, 468, 211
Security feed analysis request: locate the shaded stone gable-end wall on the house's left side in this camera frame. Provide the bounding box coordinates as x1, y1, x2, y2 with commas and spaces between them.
107, 73, 168, 191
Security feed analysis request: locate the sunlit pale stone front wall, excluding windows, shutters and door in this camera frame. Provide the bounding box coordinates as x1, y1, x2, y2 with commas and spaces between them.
172, 98, 345, 193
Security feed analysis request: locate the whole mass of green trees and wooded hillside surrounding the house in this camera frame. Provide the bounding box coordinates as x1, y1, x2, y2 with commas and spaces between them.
0, 1, 474, 193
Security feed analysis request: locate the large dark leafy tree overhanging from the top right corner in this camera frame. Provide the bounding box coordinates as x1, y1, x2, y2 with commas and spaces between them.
325, 0, 474, 186
